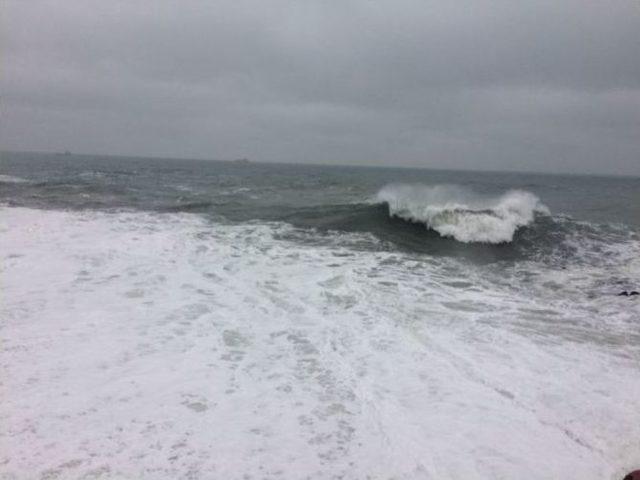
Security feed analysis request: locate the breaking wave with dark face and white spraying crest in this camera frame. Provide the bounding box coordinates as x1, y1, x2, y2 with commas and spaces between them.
272, 184, 554, 257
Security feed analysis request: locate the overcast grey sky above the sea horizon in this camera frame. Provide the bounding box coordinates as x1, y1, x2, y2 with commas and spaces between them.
0, 0, 640, 174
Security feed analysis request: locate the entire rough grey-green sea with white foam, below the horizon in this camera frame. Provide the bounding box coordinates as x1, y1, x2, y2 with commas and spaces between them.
0, 153, 640, 480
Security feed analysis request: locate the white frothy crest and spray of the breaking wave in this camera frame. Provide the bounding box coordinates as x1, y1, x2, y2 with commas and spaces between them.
377, 185, 548, 243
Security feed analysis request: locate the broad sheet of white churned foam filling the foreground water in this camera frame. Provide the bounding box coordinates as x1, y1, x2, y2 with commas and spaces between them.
0, 208, 640, 480
